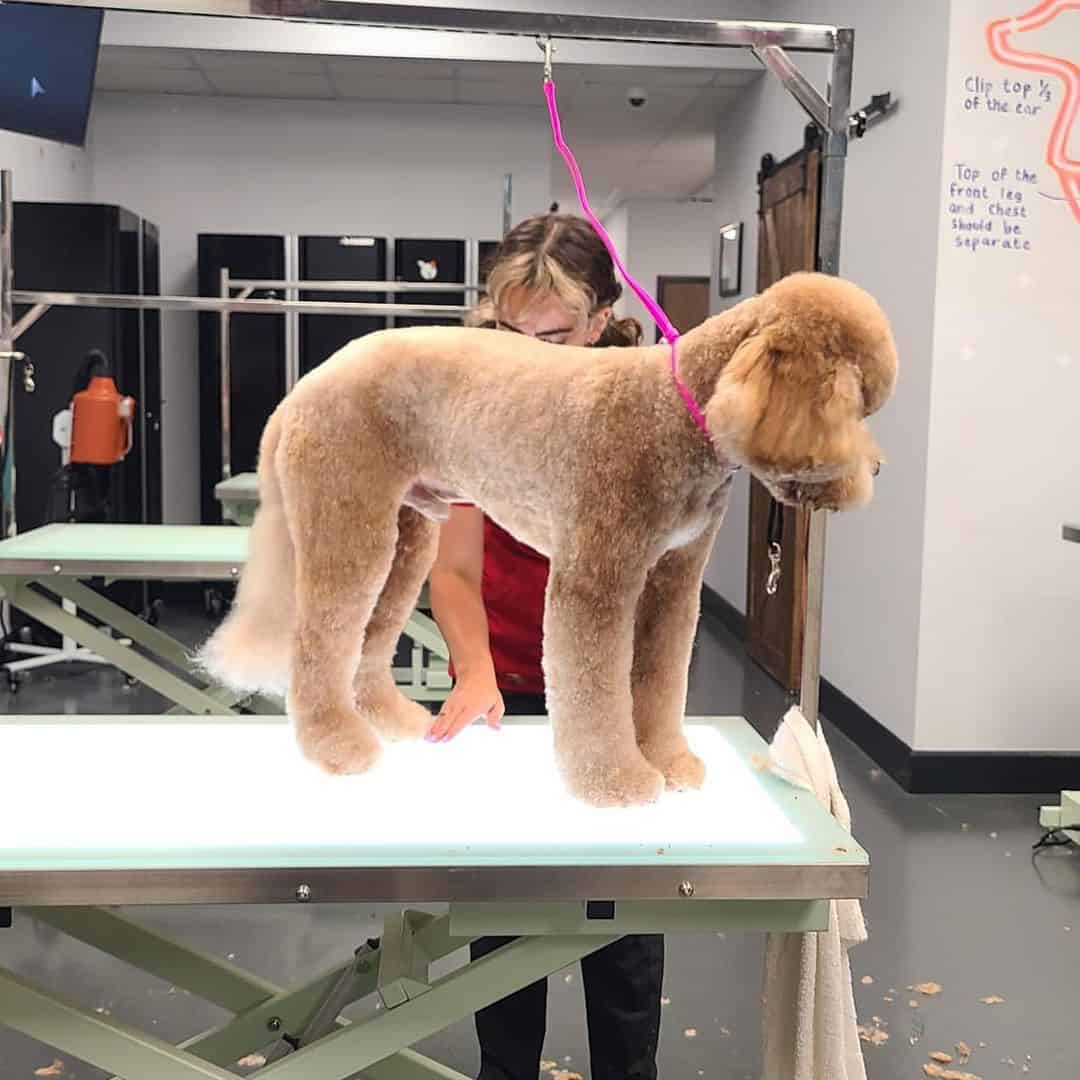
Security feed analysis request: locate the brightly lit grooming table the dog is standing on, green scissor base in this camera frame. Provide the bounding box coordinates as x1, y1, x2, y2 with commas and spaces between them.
0, 716, 868, 1080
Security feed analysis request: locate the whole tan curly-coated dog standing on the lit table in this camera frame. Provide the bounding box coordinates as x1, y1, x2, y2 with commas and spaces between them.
202, 273, 896, 806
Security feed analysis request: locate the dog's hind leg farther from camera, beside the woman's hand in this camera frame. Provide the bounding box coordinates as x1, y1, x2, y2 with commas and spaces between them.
355, 507, 438, 739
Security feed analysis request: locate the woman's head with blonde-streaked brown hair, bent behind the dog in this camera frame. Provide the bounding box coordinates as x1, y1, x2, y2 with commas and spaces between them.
487, 214, 642, 346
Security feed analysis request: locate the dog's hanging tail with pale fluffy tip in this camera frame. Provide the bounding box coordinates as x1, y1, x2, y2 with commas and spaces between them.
197, 409, 296, 696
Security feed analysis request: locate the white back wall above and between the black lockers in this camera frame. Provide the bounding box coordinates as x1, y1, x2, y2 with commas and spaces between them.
90, 94, 551, 522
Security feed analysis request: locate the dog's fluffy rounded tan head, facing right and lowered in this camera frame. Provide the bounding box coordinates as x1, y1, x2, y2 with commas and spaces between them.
705, 267, 896, 510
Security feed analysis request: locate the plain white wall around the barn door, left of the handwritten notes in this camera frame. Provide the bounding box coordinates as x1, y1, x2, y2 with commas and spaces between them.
707, 0, 948, 745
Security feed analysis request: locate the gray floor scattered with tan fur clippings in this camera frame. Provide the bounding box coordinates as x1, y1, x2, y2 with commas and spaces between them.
0, 610, 1080, 1080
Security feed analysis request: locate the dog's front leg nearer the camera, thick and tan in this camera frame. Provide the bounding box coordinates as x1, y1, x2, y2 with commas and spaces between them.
543, 541, 664, 806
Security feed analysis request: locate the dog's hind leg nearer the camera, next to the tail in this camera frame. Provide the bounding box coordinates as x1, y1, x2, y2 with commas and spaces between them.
280, 425, 408, 773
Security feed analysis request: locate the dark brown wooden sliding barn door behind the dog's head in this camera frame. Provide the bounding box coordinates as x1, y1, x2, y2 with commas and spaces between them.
746, 129, 821, 693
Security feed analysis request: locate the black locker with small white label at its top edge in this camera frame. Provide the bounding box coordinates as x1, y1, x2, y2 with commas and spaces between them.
299, 235, 388, 376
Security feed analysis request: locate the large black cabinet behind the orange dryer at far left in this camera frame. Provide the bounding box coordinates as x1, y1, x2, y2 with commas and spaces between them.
13, 202, 162, 639
